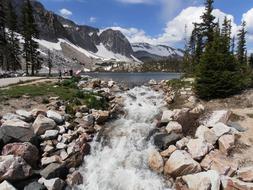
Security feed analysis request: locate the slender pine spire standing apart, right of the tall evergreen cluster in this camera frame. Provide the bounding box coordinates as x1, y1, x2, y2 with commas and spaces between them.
237, 21, 247, 65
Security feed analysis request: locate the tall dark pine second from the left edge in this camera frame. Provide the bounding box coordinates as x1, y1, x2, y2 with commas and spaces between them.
6, 1, 21, 70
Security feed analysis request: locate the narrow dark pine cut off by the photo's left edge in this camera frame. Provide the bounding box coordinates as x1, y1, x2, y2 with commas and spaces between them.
0, 0, 8, 69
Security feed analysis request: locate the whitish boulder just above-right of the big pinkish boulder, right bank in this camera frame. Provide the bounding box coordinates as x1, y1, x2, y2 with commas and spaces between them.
186, 139, 214, 161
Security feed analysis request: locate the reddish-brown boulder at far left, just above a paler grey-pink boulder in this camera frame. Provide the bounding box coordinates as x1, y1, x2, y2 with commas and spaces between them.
2, 142, 39, 167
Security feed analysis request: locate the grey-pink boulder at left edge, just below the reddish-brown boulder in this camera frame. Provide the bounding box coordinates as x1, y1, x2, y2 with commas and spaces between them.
0, 155, 32, 181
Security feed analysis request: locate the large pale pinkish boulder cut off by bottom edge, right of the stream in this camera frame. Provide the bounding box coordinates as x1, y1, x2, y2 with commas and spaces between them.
175, 170, 220, 190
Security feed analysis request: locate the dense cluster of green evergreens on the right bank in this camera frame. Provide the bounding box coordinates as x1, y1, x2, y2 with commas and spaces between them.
184, 0, 253, 99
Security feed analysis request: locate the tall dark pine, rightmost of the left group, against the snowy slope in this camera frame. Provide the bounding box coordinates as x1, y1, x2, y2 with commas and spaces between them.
22, 0, 41, 75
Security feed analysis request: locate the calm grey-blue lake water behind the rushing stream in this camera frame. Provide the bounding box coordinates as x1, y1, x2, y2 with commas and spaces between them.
84, 72, 182, 87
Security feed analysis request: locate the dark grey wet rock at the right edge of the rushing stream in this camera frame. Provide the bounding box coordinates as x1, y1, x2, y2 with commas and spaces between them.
154, 133, 183, 150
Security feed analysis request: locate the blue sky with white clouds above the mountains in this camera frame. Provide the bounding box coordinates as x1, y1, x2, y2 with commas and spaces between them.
40, 0, 253, 50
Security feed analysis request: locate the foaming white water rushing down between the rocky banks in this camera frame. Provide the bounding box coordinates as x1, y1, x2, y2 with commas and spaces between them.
79, 87, 169, 190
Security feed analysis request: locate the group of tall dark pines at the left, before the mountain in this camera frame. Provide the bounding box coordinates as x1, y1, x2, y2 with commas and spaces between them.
0, 0, 41, 75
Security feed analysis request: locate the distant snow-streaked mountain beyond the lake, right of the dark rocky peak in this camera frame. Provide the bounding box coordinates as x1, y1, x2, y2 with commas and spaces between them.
132, 43, 183, 61
